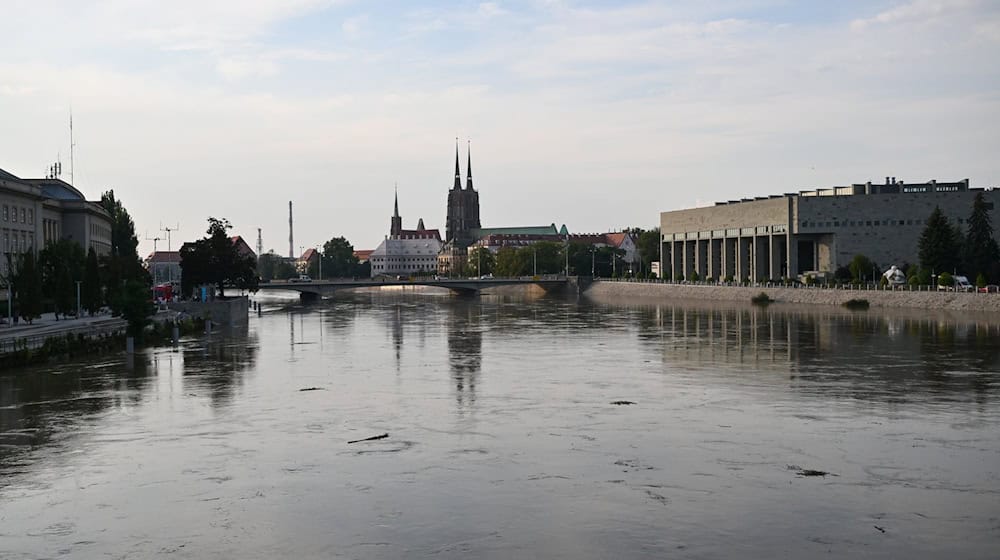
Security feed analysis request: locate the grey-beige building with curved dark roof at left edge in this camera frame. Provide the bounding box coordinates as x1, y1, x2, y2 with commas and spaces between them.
0, 169, 111, 274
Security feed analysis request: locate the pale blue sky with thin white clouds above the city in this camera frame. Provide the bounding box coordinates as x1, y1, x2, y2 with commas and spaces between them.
0, 0, 1000, 254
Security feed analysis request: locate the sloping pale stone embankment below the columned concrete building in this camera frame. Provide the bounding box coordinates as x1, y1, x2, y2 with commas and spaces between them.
584, 280, 1000, 313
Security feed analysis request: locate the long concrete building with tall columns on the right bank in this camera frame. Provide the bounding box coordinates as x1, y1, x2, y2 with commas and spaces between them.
660, 177, 1000, 280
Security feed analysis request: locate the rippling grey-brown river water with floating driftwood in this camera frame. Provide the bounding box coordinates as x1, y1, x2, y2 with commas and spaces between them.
0, 293, 1000, 559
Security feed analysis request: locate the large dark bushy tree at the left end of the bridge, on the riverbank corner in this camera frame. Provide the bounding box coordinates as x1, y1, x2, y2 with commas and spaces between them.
181, 218, 259, 297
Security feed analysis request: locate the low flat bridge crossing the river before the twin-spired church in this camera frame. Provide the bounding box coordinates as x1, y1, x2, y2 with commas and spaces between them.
260, 275, 569, 299
